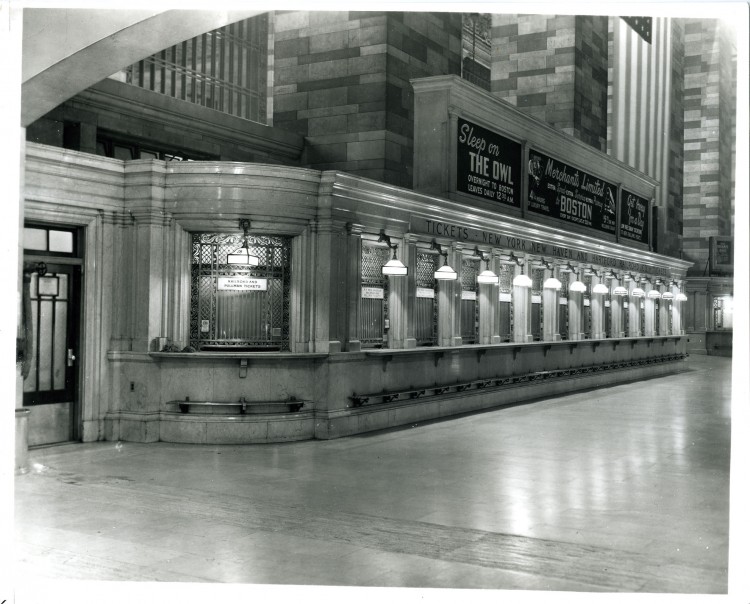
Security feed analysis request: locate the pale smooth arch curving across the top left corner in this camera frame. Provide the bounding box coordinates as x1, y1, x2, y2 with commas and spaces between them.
21, 8, 264, 127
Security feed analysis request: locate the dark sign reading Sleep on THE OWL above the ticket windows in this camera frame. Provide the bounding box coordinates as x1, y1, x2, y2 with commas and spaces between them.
456, 119, 521, 208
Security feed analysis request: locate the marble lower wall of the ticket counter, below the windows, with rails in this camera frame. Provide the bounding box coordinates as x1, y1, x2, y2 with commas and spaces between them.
105, 336, 686, 444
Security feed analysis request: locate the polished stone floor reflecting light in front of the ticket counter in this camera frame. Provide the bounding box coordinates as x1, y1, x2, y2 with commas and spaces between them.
15, 357, 731, 594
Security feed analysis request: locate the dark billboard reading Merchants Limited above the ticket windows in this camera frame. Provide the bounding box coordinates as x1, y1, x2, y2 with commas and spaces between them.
529, 149, 617, 234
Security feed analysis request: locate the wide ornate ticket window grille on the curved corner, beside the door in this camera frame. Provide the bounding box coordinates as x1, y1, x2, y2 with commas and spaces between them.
190, 233, 291, 351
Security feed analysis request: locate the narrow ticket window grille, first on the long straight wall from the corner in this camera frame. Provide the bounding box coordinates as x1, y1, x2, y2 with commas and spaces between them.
359, 242, 390, 348
